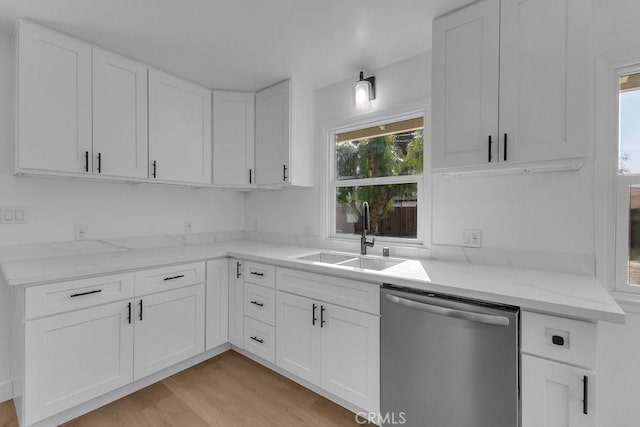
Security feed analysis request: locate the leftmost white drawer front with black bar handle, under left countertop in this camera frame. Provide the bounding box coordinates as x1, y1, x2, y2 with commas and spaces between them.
25, 273, 133, 319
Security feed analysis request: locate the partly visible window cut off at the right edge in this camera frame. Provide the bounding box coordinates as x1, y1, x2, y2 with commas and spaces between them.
616, 67, 640, 292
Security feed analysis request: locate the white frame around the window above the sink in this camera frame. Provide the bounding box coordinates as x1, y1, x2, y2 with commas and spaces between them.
323, 106, 431, 248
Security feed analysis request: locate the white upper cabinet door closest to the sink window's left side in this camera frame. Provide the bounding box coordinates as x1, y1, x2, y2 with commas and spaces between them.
256, 80, 291, 185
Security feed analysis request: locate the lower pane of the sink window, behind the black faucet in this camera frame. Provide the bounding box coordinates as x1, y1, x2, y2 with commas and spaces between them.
335, 183, 418, 239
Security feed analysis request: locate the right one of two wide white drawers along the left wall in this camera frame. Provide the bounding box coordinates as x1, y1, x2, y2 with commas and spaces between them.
136, 262, 205, 296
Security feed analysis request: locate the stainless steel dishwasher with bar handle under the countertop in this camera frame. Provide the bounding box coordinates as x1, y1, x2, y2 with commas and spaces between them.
380, 285, 520, 427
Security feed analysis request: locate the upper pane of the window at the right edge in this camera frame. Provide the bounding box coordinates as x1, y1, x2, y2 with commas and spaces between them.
618, 73, 640, 174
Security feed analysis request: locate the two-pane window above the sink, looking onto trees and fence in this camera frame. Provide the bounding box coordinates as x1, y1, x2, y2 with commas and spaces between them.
329, 117, 424, 242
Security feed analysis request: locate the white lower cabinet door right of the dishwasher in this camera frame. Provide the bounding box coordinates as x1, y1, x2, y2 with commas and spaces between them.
522, 354, 596, 427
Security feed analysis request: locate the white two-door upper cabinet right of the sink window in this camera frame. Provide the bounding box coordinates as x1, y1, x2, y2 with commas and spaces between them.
432, 0, 590, 169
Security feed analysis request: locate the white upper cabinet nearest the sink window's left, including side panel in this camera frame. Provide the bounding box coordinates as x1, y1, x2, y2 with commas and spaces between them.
256, 80, 314, 187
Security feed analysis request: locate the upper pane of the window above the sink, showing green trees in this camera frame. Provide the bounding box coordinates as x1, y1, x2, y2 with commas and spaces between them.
335, 119, 424, 180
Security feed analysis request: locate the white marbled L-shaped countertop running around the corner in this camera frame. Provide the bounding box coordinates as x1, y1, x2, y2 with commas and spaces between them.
0, 236, 625, 323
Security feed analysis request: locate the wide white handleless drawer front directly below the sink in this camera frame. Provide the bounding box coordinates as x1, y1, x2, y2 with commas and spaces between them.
276, 268, 380, 314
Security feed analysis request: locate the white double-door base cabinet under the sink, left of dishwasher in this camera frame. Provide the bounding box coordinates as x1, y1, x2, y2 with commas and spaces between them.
276, 269, 380, 413
